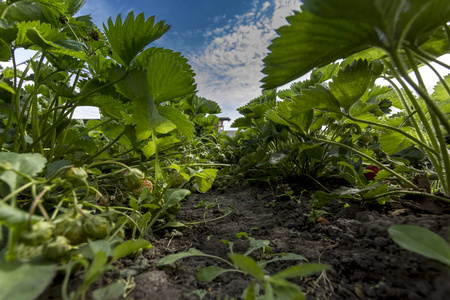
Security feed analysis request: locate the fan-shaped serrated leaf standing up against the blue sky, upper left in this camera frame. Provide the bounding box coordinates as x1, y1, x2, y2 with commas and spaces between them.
103, 11, 170, 66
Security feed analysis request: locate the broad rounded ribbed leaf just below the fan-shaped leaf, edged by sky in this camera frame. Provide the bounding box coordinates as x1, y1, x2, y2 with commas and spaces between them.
146, 51, 196, 103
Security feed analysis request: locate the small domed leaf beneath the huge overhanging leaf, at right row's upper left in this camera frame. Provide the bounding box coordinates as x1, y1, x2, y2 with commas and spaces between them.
290, 84, 340, 116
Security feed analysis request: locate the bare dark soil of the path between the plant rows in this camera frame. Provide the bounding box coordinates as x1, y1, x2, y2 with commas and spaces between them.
40, 185, 450, 300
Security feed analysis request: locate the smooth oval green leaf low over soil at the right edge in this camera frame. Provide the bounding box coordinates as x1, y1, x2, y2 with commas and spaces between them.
388, 225, 450, 266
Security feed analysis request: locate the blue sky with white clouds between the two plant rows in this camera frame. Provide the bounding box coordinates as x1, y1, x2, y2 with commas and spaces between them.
78, 0, 300, 128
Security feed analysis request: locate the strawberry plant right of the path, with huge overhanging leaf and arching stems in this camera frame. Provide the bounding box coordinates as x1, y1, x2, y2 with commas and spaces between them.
262, 0, 450, 203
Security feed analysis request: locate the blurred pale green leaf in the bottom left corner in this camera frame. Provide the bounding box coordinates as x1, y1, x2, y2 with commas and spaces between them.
0, 261, 57, 300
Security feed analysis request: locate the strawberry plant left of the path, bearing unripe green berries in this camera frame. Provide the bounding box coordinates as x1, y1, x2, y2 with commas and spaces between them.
0, 0, 220, 299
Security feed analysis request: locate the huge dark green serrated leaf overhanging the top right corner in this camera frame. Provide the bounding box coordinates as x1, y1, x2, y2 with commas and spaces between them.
262, 0, 450, 88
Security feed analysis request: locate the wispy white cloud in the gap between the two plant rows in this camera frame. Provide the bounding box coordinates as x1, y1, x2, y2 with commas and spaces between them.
188, 0, 300, 125
